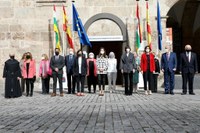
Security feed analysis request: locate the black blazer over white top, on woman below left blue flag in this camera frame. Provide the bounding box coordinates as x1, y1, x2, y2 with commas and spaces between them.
73, 57, 87, 76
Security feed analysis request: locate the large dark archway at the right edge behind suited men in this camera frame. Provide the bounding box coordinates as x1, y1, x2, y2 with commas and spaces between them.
167, 0, 200, 72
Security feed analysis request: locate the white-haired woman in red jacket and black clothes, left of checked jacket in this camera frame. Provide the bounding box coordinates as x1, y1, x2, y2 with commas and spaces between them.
87, 53, 97, 93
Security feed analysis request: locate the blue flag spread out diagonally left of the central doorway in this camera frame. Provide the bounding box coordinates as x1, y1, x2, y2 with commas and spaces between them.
72, 4, 92, 47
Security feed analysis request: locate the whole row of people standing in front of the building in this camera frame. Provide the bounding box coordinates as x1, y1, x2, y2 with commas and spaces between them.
3, 45, 198, 98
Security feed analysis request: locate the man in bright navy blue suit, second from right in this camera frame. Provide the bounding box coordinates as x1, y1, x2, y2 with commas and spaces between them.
161, 45, 177, 95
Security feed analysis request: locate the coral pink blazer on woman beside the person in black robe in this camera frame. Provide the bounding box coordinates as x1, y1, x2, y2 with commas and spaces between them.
22, 60, 36, 79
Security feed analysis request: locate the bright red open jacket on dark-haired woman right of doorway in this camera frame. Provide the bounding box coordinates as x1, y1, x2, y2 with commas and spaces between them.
140, 53, 155, 72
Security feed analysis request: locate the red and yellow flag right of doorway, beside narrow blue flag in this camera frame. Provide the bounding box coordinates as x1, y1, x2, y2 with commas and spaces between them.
146, 1, 152, 49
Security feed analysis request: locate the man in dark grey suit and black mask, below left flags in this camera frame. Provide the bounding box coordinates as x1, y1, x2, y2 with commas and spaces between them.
50, 48, 65, 97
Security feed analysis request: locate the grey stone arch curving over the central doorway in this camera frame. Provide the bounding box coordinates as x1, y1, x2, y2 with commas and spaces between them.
84, 13, 127, 42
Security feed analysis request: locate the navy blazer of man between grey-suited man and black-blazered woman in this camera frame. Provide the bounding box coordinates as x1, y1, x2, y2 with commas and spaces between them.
65, 55, 75, 73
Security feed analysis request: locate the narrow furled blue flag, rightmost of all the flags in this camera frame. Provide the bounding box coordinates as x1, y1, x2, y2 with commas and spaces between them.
157, 1, 162, 50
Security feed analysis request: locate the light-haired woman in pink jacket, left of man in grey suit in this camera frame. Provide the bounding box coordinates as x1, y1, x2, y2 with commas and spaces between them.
39, 54, 51, 94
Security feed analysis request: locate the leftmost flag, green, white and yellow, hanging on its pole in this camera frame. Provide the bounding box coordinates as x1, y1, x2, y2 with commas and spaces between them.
53, 5, 61, 51
